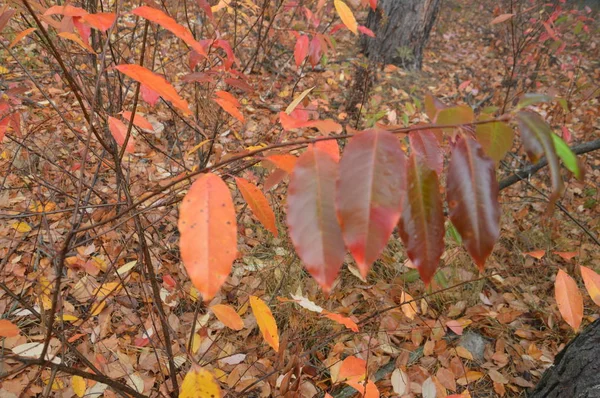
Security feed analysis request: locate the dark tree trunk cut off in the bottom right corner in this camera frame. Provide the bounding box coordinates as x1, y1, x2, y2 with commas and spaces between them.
529, 319, 600, 398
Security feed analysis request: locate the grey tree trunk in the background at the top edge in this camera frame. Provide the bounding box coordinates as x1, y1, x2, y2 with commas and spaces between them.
362, 0, 440, 69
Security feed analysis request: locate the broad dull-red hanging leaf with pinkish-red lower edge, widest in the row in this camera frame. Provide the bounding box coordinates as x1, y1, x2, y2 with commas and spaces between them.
336, 129, 406, 278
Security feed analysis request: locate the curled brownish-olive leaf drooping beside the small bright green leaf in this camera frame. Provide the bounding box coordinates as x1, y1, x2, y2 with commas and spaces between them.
516, 111, 564, 205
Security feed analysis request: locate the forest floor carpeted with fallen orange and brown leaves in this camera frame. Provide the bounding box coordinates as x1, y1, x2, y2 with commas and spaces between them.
0, 0, 600, 398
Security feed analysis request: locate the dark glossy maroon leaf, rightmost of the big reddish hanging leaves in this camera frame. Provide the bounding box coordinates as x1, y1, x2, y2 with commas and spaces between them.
446, 137, 500, 270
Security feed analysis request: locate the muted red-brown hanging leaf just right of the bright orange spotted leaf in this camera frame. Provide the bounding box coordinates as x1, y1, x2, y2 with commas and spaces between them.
287, 148, 345, 291
